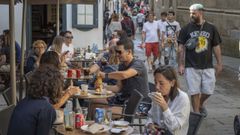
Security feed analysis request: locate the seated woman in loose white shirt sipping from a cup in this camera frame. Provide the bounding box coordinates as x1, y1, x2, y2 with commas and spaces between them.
146, 66, 190, 135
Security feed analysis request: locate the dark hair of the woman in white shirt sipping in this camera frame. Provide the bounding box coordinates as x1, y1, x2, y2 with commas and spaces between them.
153, 66, 179, 100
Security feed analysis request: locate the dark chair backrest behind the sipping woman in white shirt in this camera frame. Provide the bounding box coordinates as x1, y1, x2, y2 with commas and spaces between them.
187, 112, 203, 135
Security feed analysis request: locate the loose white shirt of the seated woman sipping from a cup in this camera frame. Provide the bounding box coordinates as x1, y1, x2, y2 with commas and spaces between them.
147, 89, 190, 135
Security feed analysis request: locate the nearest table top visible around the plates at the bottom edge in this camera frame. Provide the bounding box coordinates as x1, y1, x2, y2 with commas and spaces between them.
54, 124, 134, 135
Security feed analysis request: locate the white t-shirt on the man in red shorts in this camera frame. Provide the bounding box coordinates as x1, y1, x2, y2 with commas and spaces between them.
142, 21, 159, 43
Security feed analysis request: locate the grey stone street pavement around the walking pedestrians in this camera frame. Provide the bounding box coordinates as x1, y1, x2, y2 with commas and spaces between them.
134, 31, 240, 135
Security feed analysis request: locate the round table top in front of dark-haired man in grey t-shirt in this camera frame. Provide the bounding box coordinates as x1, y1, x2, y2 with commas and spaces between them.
73, 90, 115, 99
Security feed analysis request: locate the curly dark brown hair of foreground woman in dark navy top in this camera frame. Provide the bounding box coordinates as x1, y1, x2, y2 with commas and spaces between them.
28, 64, 64, 104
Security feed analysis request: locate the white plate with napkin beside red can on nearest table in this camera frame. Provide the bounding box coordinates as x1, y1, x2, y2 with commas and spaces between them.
81, 123, 110, 134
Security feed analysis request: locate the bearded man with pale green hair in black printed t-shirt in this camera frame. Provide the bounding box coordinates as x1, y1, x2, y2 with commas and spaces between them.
178, 4, 222, 116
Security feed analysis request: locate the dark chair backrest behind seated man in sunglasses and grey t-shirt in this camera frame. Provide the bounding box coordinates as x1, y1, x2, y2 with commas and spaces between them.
124, 90, 143, 123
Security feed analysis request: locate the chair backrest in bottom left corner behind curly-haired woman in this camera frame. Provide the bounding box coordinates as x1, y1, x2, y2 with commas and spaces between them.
0, 105, 15, 135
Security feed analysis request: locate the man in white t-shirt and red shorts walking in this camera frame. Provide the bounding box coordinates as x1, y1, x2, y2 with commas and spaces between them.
142, 13, 160, 72
